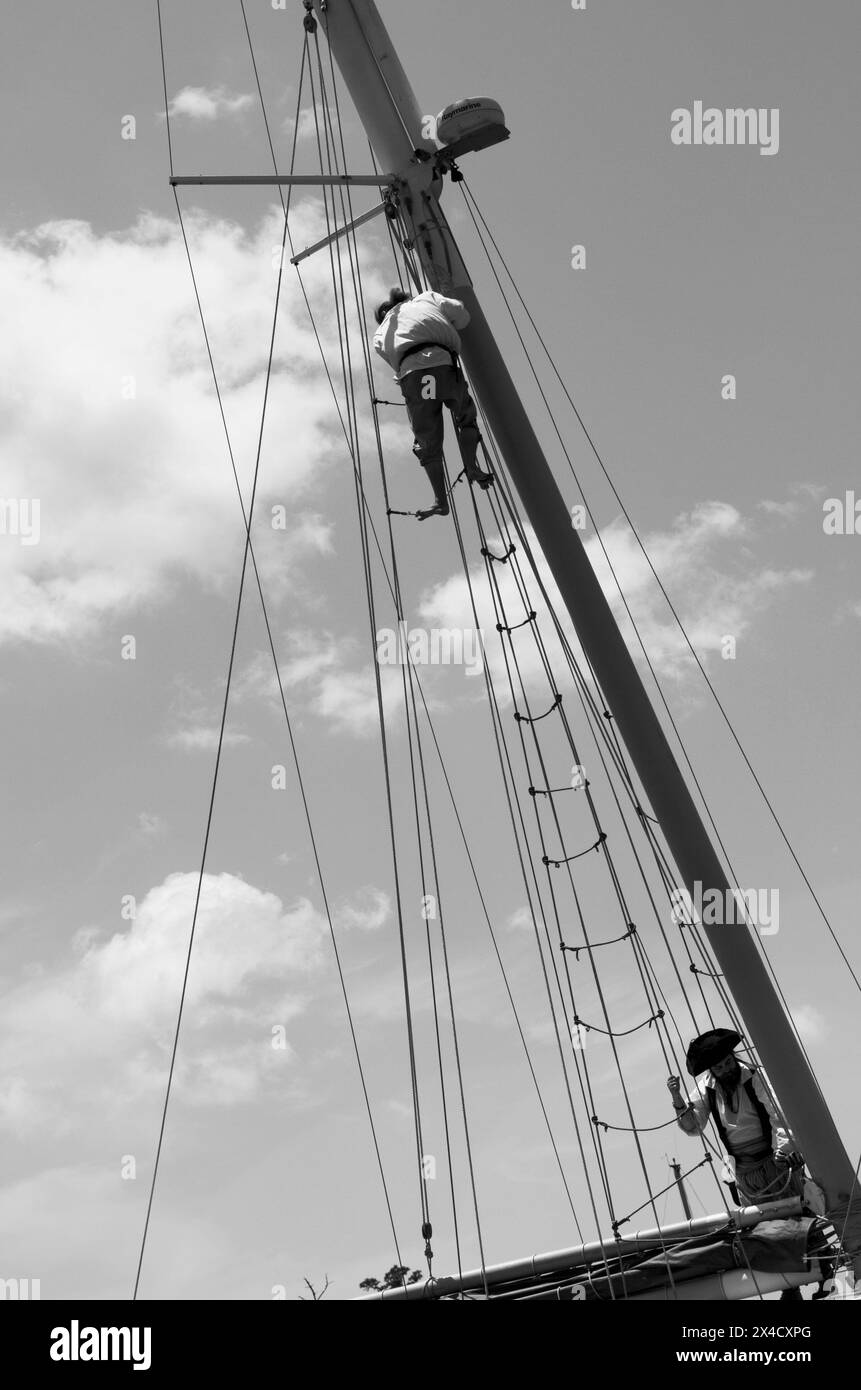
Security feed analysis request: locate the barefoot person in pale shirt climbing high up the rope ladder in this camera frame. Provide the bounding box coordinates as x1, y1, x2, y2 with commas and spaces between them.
374, 288, 494, 521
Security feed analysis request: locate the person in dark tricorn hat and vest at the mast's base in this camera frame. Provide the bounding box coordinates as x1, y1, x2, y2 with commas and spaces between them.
666, 1029, 804, 1207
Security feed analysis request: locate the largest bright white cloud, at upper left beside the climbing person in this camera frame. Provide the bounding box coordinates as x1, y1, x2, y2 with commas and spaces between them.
0, 203, 383, 642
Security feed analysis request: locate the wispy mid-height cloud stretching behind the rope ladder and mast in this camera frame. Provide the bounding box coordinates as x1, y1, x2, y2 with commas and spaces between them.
229, 502, 812, 737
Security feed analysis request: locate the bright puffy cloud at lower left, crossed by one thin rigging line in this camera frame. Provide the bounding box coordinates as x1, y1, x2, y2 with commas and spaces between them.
0, 873, 333, 1136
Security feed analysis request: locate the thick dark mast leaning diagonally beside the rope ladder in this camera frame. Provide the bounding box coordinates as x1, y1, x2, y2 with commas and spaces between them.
313, 0, 861, 1272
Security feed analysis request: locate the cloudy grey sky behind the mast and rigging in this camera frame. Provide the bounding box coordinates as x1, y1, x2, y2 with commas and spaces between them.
0, 0, 861, 1300
